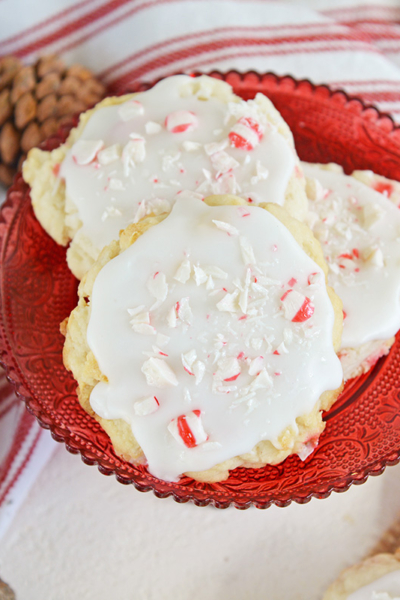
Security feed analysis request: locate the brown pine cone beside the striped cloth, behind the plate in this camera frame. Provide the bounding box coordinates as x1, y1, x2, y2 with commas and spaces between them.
0, 56, 105, 185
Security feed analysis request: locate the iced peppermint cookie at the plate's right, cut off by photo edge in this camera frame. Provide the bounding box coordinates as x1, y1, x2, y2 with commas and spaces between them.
303, 164, 400, 380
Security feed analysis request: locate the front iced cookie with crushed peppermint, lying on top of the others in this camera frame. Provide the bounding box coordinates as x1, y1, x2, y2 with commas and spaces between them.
64, 196, 343, 481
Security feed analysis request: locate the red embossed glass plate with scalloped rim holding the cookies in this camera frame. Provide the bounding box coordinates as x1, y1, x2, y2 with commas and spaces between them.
0, 72, 400, 509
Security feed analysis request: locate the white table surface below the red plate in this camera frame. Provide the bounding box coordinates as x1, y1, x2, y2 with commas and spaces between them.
0, 432, 400, 600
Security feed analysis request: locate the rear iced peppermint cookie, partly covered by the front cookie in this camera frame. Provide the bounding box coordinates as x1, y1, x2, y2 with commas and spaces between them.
23, 75, 307, 279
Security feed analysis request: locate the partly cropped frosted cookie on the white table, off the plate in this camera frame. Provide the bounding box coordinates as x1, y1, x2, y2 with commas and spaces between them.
322, 551, 400, 600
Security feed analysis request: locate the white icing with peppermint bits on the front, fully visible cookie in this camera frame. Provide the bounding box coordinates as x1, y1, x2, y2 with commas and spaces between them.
88, 200, 342, 480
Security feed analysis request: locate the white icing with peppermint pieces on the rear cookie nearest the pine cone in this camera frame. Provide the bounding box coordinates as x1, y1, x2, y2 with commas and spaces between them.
60, 75, 295, 250
